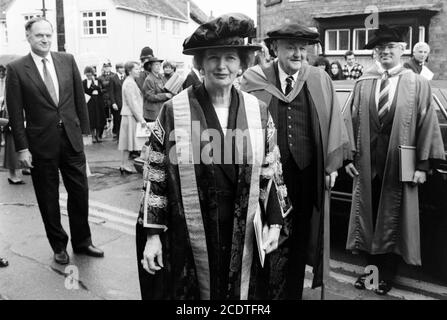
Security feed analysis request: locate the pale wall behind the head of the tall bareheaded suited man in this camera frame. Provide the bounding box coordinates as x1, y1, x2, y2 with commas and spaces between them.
0, 0, 57, 55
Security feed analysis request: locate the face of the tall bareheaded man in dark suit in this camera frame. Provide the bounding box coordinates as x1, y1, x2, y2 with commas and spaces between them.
26, 21, 53, 57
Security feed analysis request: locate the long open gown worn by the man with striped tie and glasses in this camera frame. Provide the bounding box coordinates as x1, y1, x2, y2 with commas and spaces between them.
346, 68, 445, 265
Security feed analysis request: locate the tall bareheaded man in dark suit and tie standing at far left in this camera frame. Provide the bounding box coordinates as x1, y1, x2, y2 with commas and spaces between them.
6, 18, 104, 264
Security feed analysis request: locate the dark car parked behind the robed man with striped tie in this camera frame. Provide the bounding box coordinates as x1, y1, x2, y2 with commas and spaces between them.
331, 80, 447, 281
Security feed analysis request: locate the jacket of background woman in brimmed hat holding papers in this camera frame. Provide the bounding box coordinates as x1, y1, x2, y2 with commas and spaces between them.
143, 72, 169, 121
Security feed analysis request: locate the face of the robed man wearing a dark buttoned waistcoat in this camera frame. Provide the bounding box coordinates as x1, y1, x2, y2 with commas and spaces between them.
273, 39, 307, 75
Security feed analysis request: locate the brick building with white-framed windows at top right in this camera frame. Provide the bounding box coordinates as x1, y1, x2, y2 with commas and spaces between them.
257, 0, 447, 79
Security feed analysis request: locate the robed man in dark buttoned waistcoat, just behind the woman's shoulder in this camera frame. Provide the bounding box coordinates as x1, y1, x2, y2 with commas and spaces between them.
241, 24, 349, 299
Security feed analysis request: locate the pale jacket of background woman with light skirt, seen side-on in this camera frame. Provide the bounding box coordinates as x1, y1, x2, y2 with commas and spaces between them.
121, 77, 144, 122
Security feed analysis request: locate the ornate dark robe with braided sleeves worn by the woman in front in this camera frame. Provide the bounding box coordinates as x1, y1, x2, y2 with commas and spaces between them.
137, 85, 286, 300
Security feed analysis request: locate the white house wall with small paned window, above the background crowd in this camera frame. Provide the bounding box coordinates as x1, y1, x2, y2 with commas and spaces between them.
64, 0, 190, 77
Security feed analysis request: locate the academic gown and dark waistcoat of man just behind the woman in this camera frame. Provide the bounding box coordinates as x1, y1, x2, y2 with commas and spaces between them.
241, 61, 351, 298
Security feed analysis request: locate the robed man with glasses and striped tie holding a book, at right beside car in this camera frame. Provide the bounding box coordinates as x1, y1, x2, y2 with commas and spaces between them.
346, 25, 444, 295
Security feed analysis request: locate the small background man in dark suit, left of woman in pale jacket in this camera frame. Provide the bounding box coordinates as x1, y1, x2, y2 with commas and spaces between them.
110, 63, 126, 140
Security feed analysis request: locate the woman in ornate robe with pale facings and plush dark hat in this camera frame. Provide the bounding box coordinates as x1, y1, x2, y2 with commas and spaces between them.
136, 14, 290, 300
